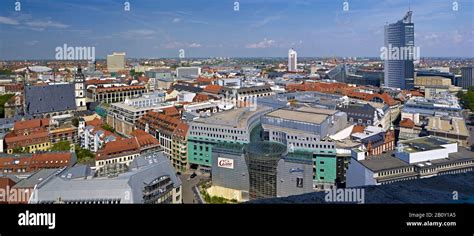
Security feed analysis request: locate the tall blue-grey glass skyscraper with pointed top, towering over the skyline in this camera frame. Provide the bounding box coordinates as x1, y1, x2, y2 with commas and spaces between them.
384, 11, 415, 89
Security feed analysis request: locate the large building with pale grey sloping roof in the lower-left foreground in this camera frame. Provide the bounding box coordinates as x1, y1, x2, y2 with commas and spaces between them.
30, 152, 182, 204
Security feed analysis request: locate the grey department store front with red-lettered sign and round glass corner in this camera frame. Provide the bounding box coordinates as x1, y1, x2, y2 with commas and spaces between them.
212, 142, 313, 201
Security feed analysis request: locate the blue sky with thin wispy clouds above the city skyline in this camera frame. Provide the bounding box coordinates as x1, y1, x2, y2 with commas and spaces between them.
0, 0, 474, 59
